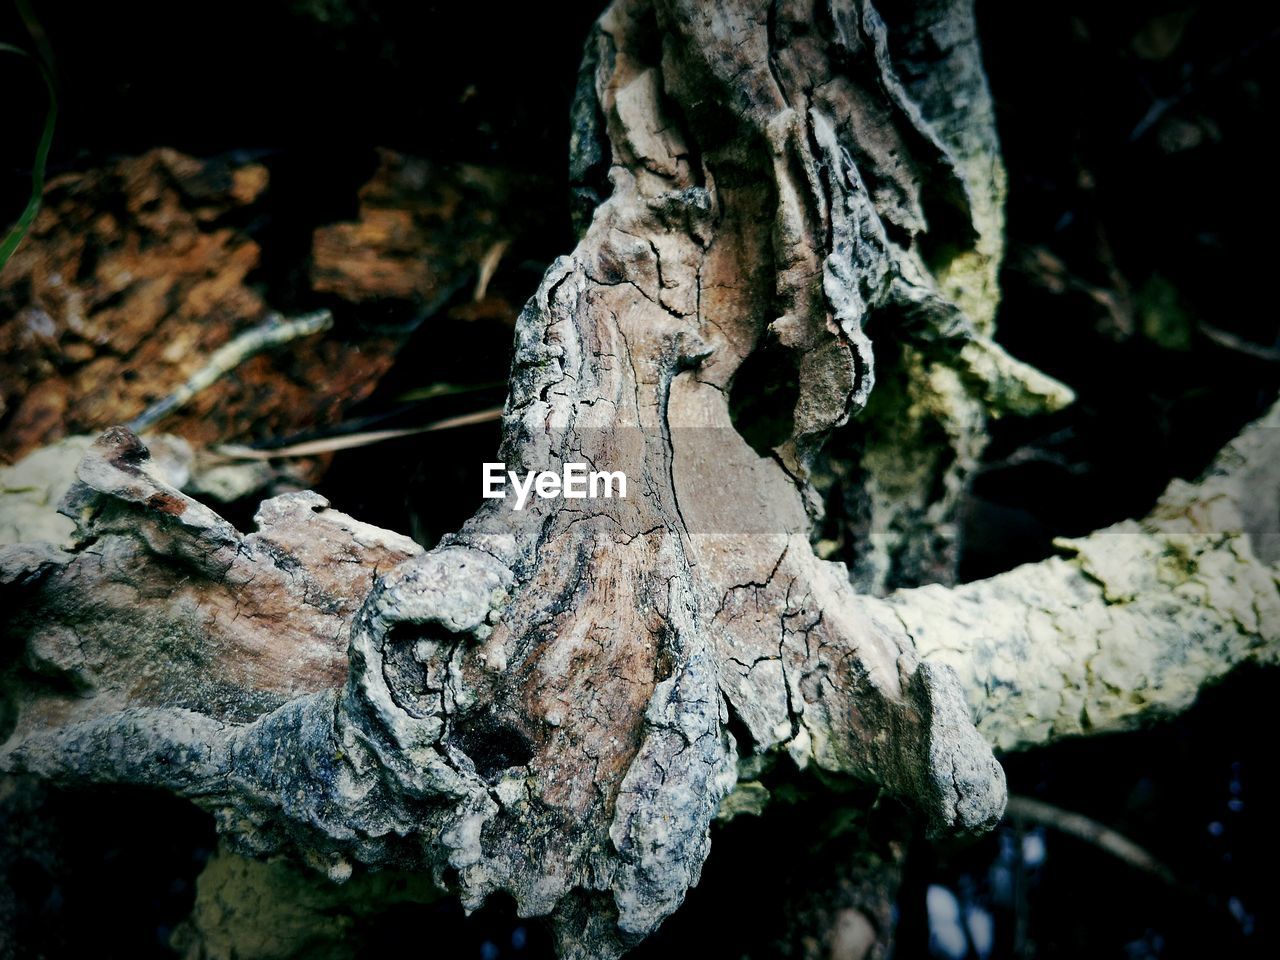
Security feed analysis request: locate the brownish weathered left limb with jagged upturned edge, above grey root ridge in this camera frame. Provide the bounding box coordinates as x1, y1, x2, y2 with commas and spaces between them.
0, 429, 421, 739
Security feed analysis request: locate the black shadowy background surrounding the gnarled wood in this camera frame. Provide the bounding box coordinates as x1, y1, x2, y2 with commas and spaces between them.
0, 0, 1280, 960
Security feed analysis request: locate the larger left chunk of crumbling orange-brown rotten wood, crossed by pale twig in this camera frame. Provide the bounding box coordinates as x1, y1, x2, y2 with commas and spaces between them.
0, 150, 381, 462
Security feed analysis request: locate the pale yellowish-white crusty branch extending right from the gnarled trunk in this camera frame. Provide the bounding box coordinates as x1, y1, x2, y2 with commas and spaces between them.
887, 404, 1280, 750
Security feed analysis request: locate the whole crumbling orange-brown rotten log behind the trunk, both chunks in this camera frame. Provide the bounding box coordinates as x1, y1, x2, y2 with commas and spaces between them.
0, 150, 529, 471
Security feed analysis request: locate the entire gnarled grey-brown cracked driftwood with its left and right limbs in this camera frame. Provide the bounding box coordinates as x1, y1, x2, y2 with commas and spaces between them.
0, 0, 1280, 956
